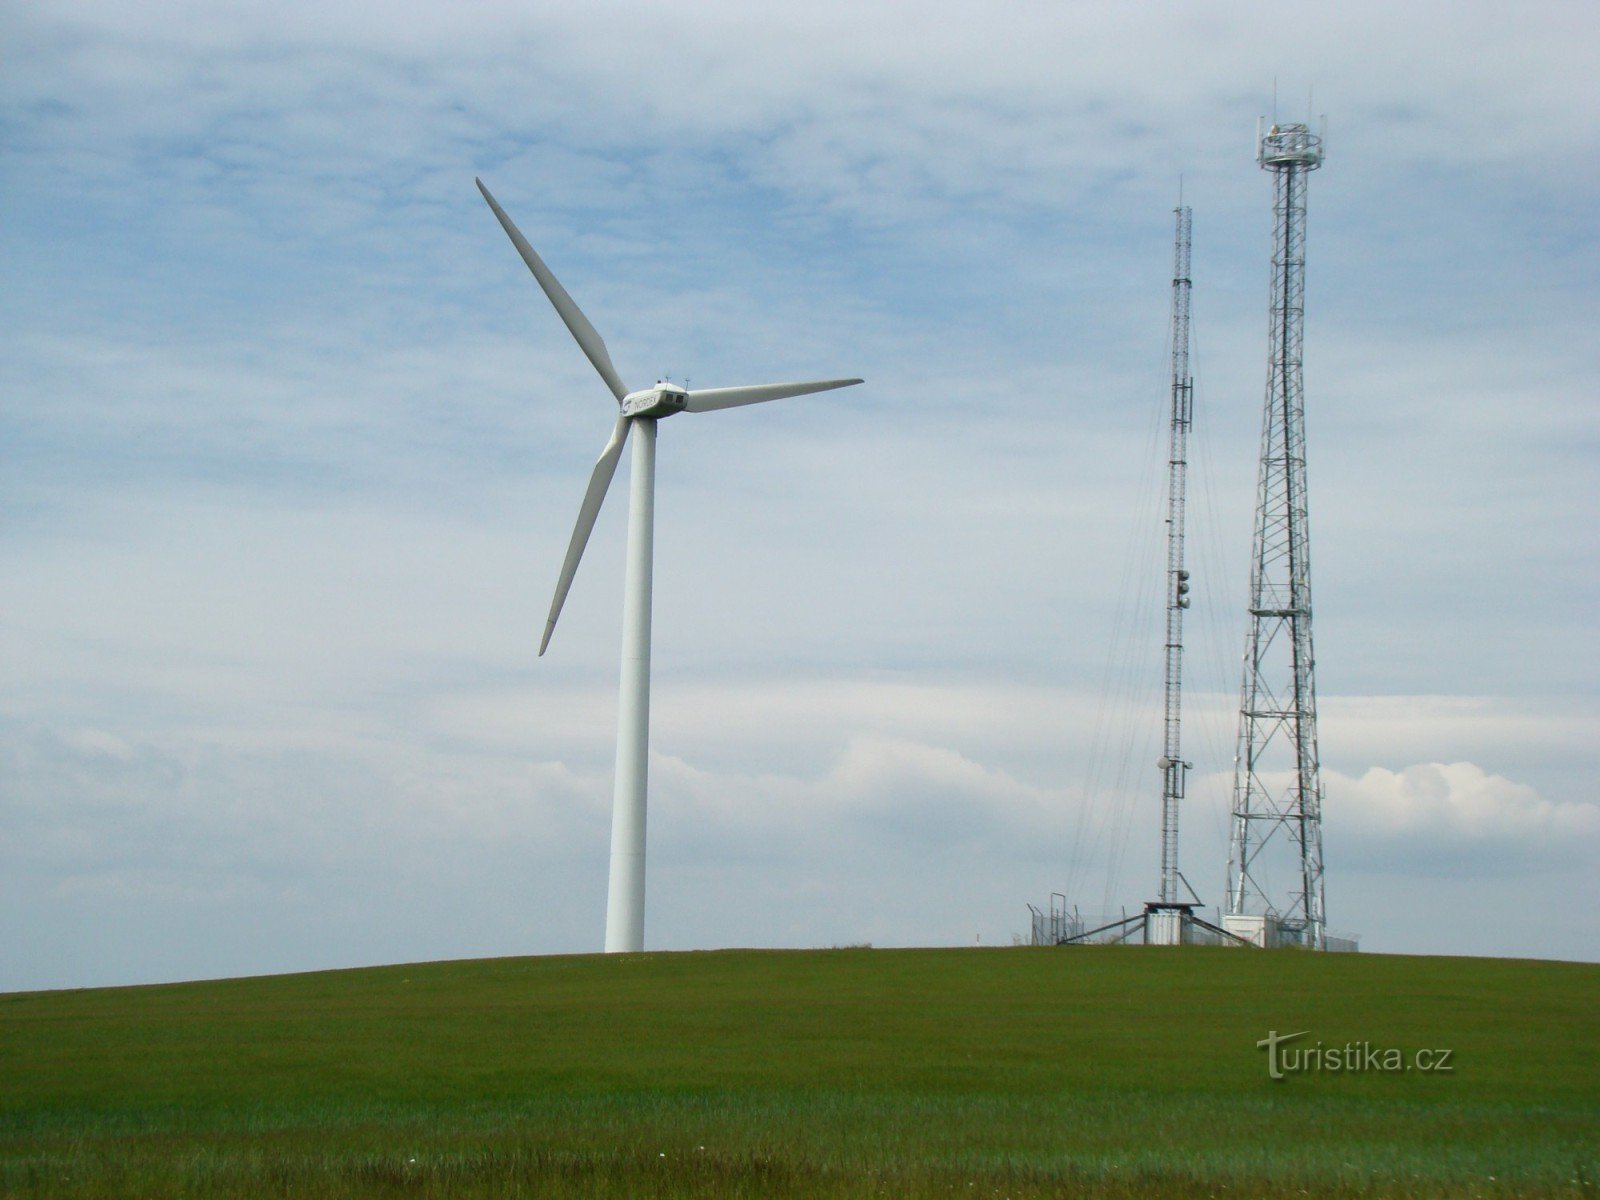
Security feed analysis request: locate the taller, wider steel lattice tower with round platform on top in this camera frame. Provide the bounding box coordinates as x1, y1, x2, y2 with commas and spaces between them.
1222, 125, 1326, 950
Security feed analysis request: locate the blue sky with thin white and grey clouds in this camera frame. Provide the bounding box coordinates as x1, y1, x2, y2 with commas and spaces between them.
0, 0, 1600, 990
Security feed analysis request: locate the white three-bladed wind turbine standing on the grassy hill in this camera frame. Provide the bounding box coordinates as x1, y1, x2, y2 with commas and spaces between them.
475, 179, 861, 954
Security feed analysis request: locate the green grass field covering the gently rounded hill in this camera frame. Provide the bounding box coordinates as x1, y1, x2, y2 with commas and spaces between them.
0, 947, 1600, 1197
